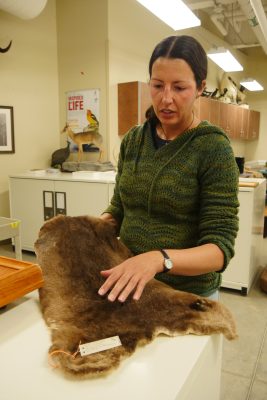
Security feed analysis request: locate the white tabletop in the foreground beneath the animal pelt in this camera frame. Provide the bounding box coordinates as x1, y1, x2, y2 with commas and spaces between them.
0, 292, 222, 400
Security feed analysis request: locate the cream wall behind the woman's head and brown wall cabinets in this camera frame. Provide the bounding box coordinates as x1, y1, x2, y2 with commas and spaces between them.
108, 0, 253, 162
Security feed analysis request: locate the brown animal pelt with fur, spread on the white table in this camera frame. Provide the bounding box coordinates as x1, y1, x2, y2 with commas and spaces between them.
35, 216, 236, 376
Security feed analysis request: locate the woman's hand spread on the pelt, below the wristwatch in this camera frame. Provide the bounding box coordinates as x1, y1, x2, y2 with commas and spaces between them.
98, 250, 163, 302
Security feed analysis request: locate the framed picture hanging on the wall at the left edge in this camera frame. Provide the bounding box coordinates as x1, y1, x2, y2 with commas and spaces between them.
0, 106, 15, 153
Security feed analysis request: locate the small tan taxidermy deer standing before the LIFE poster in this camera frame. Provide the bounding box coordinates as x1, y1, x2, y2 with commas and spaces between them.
62, 123, 103, 161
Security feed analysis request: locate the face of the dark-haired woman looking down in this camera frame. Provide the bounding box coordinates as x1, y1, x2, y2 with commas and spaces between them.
150, 57, 206, 127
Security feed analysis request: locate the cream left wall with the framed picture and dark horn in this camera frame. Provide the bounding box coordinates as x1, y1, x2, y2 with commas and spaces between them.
0, 0, 59, 217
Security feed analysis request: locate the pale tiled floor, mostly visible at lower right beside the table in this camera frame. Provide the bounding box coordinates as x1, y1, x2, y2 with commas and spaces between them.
0, 238, 267, 400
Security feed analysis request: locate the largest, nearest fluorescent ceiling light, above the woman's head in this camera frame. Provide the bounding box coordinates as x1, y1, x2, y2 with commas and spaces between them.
137, 0, 201, 31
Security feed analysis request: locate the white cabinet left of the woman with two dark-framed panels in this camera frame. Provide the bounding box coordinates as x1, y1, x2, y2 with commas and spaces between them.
9, 173, 114, 251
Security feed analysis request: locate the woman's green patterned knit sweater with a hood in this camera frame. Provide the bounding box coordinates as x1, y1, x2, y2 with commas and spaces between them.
105, 121, 239, 296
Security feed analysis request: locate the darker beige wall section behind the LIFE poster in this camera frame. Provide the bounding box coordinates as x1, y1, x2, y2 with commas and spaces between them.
57, 0, 108, 159
